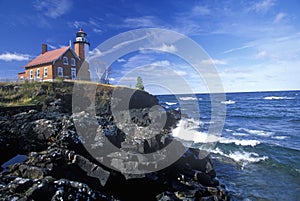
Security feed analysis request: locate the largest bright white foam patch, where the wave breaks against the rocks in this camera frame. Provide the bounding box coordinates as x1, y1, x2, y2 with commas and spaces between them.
172, 119, 219, 143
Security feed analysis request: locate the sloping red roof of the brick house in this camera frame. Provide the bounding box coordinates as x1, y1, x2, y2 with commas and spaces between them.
25, 46, 70, 68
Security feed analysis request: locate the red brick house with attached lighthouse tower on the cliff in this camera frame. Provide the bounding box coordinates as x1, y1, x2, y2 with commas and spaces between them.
18, 29, 90, 81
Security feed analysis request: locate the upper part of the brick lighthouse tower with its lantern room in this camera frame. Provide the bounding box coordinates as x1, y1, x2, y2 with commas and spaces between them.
74, 28, 90, 61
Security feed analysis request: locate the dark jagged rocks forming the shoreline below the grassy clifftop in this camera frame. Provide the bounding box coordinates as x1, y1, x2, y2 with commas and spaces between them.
0, 82, 229, 201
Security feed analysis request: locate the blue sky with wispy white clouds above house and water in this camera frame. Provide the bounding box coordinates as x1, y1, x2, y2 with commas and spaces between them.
0, 0, 300, 94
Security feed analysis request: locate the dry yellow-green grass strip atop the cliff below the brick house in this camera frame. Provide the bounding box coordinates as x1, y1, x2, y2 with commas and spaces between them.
0, 79, 141, 107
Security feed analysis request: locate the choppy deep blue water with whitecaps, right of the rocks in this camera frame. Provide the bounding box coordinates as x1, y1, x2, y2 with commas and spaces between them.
158, 91, 300, 201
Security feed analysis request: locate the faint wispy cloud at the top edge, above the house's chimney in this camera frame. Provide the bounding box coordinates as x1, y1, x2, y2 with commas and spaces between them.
33, 0, 72, 19
